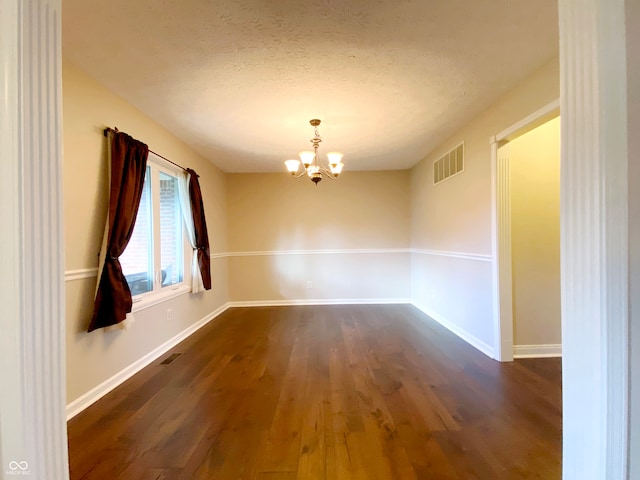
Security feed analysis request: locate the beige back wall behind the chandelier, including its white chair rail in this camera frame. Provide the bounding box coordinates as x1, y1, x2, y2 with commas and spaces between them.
227, 171, 411, 301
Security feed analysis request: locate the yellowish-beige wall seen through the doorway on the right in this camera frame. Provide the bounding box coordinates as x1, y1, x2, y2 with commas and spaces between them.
498, 117, 561, 346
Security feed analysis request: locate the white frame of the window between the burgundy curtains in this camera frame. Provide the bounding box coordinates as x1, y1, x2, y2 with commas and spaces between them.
131, 152, 191, 313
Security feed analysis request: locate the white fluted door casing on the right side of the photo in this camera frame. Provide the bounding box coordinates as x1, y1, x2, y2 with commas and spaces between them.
559, 0, 629, 480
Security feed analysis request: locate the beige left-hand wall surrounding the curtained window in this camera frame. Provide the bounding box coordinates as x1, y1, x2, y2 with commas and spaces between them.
62, 61, 228, 403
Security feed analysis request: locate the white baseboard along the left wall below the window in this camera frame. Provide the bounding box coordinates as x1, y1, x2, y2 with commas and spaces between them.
66, 302, 230, 421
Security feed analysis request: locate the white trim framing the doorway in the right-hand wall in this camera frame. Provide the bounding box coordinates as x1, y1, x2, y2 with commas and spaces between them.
489, 99, 560, 362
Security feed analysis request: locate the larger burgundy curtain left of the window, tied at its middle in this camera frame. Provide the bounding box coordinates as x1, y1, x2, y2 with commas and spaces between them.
89, 132, 149, 332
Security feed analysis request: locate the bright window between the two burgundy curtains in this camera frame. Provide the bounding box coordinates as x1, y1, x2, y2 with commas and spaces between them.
120, 153, 188, 302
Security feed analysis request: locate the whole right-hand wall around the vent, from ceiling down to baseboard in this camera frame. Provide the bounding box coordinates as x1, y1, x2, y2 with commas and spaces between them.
410, 60, 559, 354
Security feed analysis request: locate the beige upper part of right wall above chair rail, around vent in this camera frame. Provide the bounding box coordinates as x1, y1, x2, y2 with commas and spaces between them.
411, 59, 560, 254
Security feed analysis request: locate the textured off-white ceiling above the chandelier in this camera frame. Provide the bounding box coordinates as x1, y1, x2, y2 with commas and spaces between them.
63, 0, 558, 172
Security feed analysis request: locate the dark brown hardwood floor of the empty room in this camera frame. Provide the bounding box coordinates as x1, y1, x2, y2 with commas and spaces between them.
68, 305, 561, 480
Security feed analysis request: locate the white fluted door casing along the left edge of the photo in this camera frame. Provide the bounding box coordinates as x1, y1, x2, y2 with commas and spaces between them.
0, 0, 68, 480
